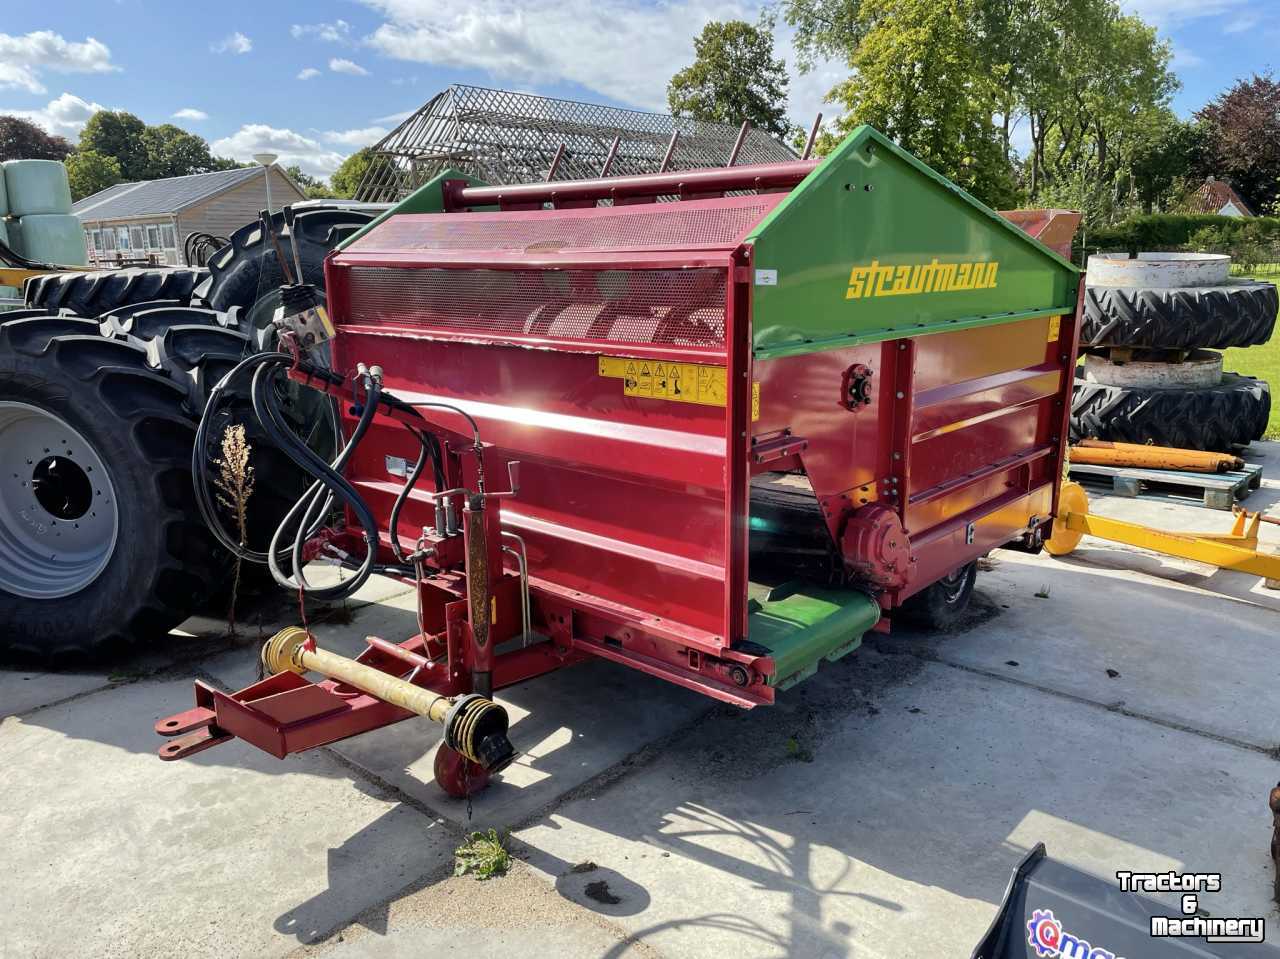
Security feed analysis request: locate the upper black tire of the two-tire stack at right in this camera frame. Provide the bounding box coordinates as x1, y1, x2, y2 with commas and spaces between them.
1080, 280, 1277, 350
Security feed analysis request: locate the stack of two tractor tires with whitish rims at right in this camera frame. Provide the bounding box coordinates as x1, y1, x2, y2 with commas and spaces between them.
1071, 254, 1277, 452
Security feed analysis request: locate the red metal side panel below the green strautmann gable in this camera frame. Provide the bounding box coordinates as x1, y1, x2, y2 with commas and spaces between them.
755, 307, 1076, 602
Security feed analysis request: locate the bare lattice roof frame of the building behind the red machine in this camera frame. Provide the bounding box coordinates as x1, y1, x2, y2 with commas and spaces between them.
356, 83, 796, 202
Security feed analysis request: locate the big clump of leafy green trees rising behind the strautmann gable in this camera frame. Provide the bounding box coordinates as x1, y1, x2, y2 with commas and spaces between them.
782, 0, 1189, 220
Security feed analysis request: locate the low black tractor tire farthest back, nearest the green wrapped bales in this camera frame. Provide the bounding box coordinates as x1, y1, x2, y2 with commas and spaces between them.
23, 266, 209, 316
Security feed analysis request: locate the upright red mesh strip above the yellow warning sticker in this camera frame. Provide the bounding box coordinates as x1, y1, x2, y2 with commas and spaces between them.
344, 266, 726, 347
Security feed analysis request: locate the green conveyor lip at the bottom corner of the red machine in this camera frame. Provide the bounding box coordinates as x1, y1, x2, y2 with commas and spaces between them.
748, 584, 881, 689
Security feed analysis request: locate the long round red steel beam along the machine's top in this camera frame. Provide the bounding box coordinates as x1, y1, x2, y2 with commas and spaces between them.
444, 160, 820, 211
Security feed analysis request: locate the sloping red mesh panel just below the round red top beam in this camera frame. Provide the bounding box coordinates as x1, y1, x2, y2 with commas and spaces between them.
349, 193, 782, 252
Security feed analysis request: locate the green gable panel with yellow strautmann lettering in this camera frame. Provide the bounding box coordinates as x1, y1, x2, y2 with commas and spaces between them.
748, 125, 1079, 357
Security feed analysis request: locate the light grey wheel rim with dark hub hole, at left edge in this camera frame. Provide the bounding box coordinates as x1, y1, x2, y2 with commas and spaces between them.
0, 401, 120, 599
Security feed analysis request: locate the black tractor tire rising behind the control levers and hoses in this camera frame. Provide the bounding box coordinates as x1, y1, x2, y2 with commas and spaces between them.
196, 207, 374, 311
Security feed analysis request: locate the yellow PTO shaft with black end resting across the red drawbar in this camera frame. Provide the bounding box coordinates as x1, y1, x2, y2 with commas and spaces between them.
262, 626, 516, 772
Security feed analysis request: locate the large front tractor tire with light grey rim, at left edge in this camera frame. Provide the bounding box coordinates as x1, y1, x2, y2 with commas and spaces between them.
0, 316, 228, 666
